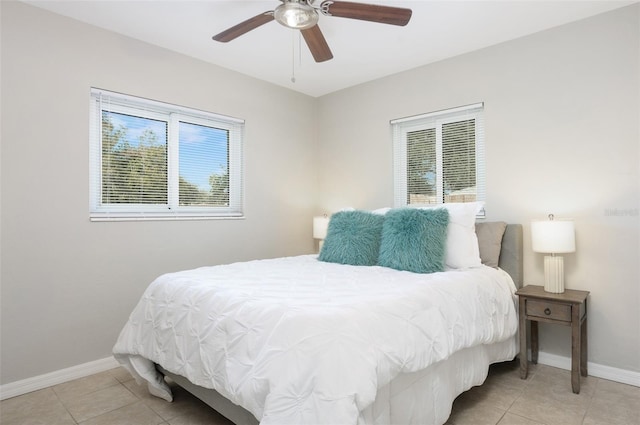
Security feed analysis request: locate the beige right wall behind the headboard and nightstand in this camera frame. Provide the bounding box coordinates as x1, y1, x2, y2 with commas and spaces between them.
318, 4, 640, 372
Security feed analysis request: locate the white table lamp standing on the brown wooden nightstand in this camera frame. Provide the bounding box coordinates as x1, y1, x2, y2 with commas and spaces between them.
531, 214, 576, 294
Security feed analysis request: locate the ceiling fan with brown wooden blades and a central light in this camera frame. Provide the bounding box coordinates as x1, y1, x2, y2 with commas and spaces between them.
213, 0, 411, 62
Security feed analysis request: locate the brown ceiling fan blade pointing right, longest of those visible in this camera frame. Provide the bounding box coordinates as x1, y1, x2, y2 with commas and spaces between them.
320, 0, 411, 27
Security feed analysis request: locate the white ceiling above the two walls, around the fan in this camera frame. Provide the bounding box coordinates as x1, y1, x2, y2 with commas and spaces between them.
23, 0, 638, 96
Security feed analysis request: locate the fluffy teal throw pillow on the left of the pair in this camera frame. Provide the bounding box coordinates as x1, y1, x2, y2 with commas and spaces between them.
318, 210, 385, 266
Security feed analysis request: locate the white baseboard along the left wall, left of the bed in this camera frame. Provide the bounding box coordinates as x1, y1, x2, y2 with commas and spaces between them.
0, 357, 119, 400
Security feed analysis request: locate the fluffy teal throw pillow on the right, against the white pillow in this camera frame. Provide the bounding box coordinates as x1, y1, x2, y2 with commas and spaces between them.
378, 208, 449, 273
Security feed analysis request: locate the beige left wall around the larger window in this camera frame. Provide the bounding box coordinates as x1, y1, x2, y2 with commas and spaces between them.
0, 1, 317, 384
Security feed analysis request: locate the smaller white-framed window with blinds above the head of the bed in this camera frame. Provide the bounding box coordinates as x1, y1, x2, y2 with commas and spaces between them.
391, 103, 485, 212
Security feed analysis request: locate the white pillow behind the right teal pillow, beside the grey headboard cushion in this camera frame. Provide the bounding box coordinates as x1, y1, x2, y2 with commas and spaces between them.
373, 202, 484, 269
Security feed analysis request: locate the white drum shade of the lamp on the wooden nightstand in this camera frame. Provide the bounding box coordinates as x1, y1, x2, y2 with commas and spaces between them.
531, 220, 576, 254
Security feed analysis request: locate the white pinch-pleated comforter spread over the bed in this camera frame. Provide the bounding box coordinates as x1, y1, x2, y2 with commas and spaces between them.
114, 256, 517, 425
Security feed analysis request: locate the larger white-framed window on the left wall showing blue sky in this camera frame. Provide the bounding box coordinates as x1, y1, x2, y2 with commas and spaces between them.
90, 89, 244, 220
